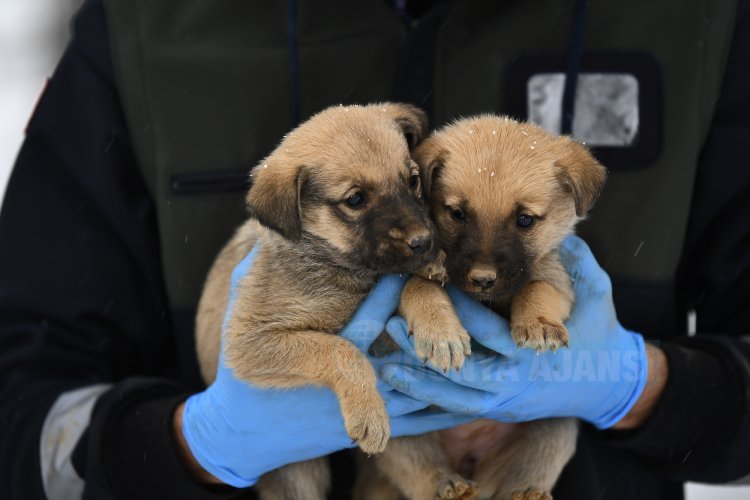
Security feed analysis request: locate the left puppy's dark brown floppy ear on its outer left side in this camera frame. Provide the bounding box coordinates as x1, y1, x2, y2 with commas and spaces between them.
246, 159, 306, 241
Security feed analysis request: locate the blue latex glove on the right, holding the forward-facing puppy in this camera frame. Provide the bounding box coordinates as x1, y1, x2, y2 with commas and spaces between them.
381, 237, 647, 429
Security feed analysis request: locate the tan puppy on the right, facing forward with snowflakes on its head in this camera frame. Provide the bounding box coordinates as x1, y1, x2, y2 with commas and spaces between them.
356, 115, 606, 500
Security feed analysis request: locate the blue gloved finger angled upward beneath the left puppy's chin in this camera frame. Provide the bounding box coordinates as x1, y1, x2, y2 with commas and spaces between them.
341, 274, 406, 352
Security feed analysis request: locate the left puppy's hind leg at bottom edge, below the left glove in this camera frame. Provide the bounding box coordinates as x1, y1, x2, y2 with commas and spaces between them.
256, 457, 331, 500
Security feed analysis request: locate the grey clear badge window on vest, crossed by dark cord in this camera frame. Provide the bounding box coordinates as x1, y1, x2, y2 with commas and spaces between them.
527, 73, 639, 147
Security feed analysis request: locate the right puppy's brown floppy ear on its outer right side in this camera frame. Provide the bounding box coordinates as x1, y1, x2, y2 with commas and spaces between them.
555, 137, 607, 217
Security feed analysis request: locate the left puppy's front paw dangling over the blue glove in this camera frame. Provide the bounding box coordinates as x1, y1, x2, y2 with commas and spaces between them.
341, 396, 391, 455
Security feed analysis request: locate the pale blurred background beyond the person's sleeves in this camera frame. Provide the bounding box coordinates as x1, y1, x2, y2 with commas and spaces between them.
0, 0, 750, 500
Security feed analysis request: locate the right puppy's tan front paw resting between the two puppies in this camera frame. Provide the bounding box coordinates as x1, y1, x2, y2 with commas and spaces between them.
409, 315, 471, 372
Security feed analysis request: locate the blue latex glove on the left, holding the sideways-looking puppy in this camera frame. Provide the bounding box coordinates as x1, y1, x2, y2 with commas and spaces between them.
182, 246, 466, 487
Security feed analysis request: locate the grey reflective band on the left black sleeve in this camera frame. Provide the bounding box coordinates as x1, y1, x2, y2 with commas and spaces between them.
39, 384, 112, 500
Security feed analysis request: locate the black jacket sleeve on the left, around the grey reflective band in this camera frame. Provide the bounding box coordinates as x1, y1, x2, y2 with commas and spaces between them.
0, 1, 253, 499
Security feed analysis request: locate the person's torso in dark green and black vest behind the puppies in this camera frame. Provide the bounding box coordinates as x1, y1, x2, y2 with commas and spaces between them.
106, 0, 734, 499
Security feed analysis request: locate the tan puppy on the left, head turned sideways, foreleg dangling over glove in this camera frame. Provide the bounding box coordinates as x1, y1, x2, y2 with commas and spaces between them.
196, 103, 437, 499
